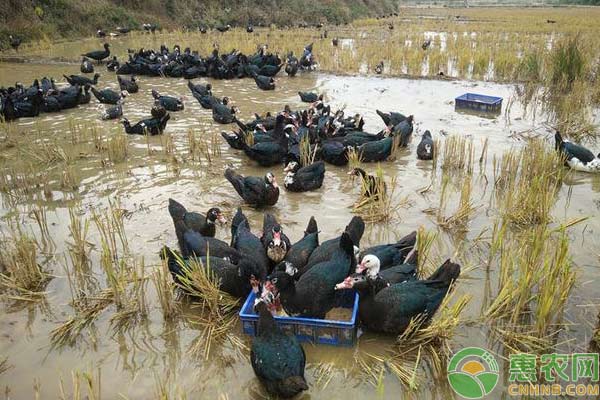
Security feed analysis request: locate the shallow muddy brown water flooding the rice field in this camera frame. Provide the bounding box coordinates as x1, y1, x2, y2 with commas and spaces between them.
0, 53, 600, 399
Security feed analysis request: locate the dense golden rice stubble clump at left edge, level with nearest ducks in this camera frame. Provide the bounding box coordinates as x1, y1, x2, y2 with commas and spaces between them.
0, 231, 51, 301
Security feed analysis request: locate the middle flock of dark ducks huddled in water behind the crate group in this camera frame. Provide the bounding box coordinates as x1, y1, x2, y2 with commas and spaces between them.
221, 92, 434, 207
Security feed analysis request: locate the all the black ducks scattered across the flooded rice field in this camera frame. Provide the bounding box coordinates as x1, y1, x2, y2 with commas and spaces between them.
0, 29, 600, 397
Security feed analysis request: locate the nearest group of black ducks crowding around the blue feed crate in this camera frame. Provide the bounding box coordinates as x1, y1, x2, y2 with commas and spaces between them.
161, 199, 460, 398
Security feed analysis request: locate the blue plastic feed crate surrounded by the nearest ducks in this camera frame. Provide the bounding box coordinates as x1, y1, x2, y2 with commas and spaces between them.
240, 290, 358, 346
